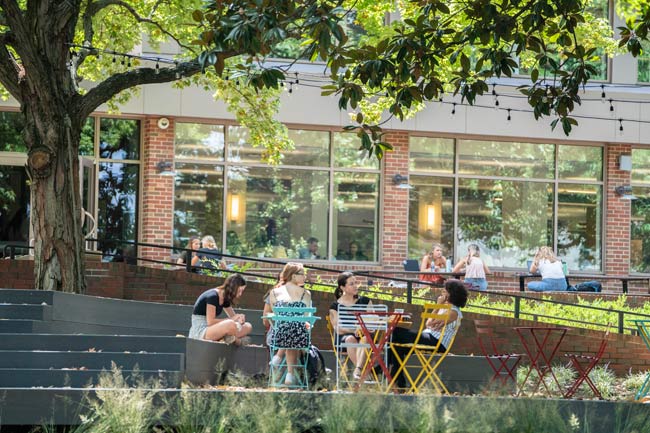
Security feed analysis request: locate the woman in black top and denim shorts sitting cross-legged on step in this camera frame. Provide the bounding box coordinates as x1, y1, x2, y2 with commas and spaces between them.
190, 274, 253, 346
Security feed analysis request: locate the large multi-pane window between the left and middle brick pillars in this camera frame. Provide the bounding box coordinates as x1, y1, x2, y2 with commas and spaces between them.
174, 123, 379, 261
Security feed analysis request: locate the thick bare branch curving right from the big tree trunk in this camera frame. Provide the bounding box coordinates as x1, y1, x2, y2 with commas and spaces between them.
77, 61, 201, 119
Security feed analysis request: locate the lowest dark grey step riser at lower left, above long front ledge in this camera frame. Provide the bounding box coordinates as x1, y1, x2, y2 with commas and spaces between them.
0, 368, 183, 388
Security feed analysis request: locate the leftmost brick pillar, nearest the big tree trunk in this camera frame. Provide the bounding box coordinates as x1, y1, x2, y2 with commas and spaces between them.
139, 117, 174, 264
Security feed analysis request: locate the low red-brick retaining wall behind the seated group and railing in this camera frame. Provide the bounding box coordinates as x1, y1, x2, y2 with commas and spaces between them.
0, 260, 650, 375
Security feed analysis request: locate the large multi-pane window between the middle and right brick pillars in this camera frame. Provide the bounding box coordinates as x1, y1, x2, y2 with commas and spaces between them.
409, 137, 603, 270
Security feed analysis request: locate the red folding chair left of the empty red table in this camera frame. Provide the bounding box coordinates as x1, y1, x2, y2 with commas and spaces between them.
474, 320, 523, 386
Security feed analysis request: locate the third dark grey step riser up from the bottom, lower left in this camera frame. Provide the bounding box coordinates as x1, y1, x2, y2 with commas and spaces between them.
0, 333, 185, 353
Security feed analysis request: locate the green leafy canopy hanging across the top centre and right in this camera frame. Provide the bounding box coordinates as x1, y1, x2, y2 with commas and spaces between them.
195, 0, 650, 158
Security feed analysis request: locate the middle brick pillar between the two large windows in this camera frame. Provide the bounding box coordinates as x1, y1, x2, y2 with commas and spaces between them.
381, 131, 409, 269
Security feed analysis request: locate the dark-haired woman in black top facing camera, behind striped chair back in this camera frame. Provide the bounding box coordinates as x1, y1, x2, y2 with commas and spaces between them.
329, 272, 372, 379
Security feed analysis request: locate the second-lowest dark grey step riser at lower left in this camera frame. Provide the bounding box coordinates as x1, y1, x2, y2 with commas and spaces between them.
0, 350, 185, 371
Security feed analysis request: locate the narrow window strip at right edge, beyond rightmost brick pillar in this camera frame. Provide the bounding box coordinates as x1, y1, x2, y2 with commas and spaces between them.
630, 149, 650, 273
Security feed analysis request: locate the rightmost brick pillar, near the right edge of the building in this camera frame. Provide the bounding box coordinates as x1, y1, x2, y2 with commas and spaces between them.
603, 144, 632, 275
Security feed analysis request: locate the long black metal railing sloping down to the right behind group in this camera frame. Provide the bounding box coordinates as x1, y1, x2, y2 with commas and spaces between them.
3, 239, 650, 334
